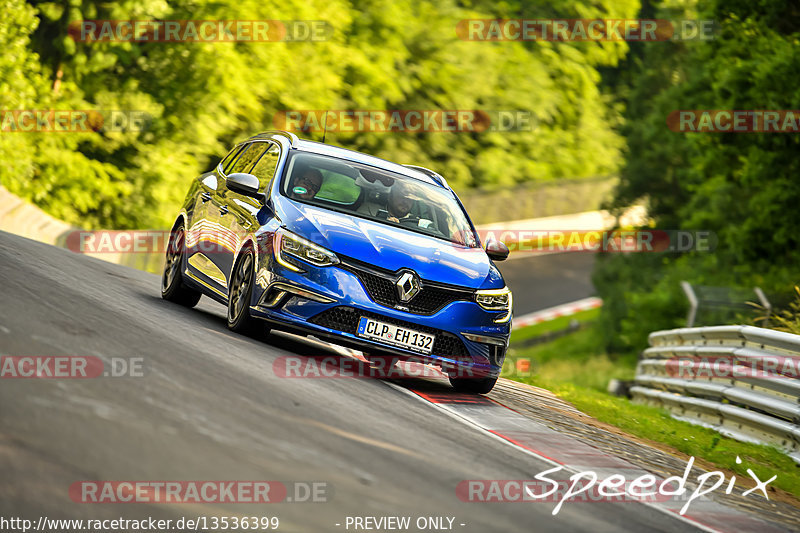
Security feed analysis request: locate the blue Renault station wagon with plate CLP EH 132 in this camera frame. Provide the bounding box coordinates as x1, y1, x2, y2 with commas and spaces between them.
161, 132, 512, 393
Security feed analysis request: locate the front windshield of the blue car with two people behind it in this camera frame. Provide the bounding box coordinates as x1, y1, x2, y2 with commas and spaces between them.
281, 152, 478, 248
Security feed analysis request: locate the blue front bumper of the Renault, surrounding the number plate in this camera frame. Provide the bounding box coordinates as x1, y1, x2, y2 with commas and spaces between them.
250, 254, 511, 377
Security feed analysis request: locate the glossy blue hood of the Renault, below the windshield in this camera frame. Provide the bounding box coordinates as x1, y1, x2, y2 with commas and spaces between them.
279, 198, 504, 289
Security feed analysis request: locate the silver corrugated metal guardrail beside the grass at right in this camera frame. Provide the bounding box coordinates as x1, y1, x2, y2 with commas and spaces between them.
630, 326, 800, 463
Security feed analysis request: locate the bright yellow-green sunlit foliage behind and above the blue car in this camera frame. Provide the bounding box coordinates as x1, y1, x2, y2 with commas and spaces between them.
0, 0, 637, 228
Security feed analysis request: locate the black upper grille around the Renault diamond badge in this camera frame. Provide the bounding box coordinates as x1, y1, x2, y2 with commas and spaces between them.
341, 260, 473, 315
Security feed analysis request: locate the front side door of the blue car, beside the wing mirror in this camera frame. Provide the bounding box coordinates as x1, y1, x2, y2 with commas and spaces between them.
214, 140, 272, 287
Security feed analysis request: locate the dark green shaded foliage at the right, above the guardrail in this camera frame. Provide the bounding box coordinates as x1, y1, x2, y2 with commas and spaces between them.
595, 0, 800, 351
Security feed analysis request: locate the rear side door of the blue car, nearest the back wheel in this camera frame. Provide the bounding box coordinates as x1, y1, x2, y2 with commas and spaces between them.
186, 145, 245, 293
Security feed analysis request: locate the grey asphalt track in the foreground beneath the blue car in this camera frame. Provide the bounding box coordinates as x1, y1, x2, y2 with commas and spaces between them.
0, 232, 692, 532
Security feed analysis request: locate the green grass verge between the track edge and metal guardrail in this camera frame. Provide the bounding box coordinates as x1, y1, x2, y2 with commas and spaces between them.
504, 317, 800, 497
